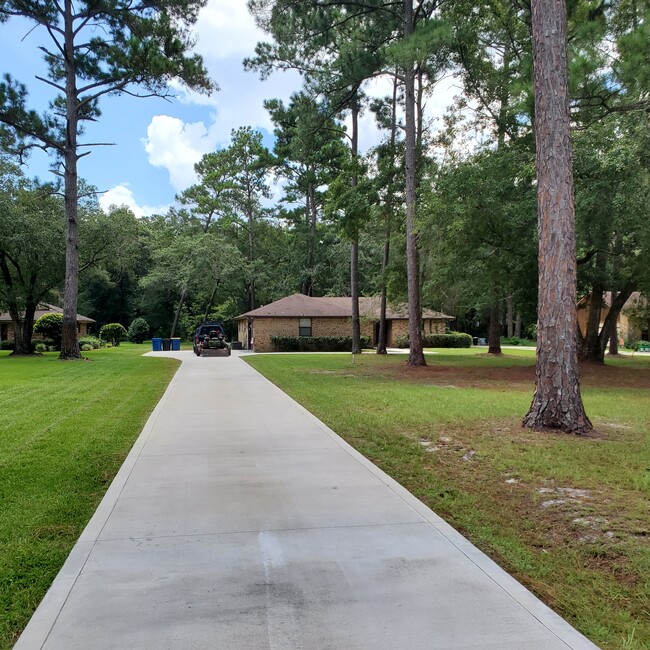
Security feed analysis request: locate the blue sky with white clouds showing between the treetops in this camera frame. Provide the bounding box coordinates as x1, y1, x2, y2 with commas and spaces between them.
0, 0, 452, 216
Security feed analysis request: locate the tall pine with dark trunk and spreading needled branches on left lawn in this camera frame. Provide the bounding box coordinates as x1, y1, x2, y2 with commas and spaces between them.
0, 0, 214, 359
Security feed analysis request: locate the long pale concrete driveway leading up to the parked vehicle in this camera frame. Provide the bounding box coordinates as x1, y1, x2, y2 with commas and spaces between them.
16, 352, 595, 650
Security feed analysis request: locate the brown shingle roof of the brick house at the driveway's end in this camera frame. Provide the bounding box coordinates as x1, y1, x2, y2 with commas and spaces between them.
236, 293, 454, 320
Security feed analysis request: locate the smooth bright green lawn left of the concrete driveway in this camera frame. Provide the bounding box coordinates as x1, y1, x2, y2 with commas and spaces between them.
0, 344, 178, 650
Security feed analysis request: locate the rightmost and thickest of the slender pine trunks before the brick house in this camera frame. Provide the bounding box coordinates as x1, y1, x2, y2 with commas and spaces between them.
404, 0, 427, 366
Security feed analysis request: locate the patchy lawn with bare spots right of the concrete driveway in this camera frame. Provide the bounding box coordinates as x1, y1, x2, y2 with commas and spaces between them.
246, 350, 650, 650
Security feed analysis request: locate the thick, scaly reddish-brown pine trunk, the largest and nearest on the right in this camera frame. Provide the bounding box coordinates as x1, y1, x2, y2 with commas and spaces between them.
523, 0, 593, 434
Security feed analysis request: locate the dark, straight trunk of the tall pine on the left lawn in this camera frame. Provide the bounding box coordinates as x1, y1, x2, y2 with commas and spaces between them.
59, 0, 81, 359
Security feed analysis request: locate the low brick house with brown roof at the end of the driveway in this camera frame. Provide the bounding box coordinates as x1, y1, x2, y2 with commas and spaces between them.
235, 293, 454, 352
